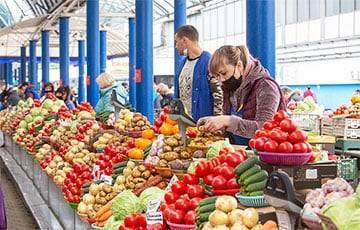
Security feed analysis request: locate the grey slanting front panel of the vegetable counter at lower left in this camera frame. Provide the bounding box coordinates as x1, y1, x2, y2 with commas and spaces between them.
0, 133, 92, 230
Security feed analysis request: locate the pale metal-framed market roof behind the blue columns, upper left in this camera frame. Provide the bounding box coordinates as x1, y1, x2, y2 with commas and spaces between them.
0, 0, 210, 58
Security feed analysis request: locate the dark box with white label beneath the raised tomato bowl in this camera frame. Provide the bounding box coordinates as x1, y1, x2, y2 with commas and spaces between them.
262, 163, 337, 190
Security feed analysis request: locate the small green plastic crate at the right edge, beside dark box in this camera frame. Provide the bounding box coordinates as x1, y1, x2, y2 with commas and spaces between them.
337, 158, 358, 180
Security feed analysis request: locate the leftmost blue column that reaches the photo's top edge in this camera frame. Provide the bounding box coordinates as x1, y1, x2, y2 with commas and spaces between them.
86, 0, 100, 106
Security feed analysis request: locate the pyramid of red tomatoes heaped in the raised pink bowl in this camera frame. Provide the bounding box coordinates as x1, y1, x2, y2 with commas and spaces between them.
249, 111, 312, 153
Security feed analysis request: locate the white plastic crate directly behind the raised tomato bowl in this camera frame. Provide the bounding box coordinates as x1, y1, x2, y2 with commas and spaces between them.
291, 114, 321, 134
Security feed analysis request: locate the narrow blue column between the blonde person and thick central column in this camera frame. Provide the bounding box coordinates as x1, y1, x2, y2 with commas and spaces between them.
129, 18, 136, 108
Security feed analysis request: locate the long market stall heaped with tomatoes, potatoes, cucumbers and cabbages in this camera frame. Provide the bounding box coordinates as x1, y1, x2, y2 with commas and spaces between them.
0, 92, 358, 230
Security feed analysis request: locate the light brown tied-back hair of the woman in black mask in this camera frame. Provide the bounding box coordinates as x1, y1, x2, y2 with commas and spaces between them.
209, 45, 252, 76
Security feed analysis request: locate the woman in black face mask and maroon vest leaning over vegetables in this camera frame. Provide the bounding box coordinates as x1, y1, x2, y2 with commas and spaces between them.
198, 46, 285, 145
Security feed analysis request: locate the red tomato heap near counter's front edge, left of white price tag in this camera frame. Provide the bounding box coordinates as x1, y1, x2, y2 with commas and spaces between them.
62, 163, 93, 203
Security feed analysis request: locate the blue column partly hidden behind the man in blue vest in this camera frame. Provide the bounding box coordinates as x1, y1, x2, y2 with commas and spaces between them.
174, 0, 186, 97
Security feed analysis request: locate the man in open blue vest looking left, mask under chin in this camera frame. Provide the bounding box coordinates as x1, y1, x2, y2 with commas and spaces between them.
175, 25, 222, 121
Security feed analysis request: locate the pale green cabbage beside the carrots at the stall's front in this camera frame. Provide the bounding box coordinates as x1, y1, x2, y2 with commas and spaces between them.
111, 190, 141, 221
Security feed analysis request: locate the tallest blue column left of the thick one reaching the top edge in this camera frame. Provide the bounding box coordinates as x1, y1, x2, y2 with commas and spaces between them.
60, 17, 70, 86
